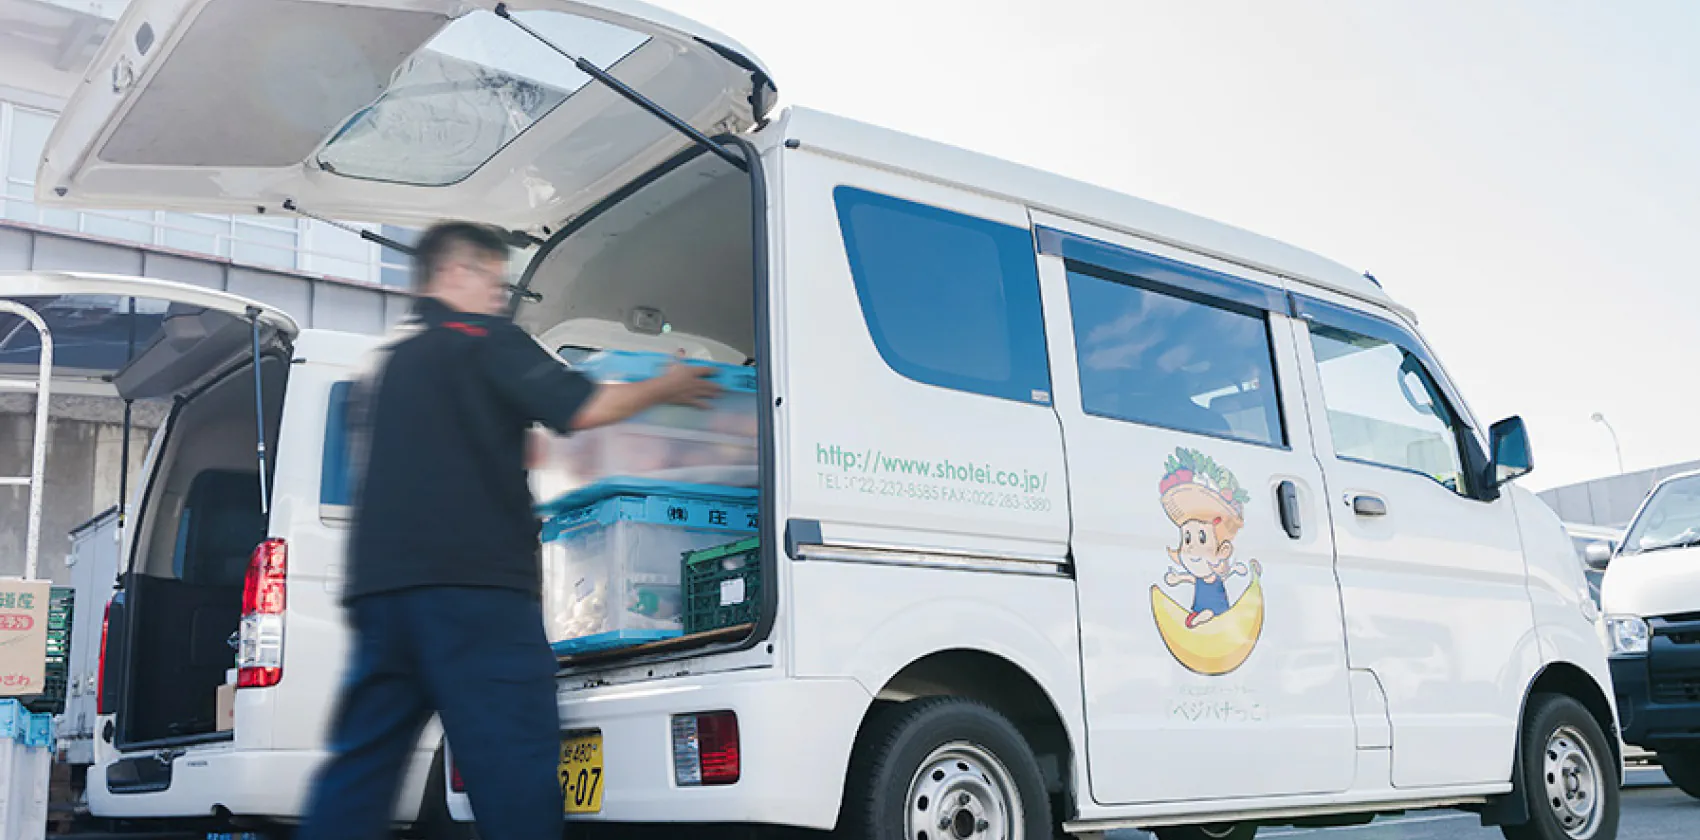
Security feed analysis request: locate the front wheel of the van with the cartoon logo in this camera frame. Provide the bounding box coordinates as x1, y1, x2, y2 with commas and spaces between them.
1499, 694, 1622, 840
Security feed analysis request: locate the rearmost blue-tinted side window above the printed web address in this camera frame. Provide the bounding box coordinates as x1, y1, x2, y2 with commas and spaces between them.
833, 187, 1051, 405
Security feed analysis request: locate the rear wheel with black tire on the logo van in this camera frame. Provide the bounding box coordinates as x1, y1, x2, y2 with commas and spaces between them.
836, 697, 1054, 840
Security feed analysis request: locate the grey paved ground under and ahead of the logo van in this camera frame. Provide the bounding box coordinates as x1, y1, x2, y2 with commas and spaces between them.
1110, 770, 1700, 840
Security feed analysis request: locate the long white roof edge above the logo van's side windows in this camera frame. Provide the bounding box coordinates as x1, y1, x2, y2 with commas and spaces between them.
784, 105, 1416, 321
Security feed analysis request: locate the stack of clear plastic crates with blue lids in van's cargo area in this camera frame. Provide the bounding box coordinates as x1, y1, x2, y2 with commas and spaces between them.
534, 352, 758, 656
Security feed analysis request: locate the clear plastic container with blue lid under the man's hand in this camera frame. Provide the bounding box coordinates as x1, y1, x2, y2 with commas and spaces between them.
532, 350, 757, 498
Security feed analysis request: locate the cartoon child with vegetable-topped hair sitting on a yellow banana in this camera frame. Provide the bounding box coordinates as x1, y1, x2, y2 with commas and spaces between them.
1151, 449, 1263, 677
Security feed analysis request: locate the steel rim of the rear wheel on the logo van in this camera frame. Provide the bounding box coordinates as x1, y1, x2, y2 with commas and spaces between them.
903, 741, 1025, 840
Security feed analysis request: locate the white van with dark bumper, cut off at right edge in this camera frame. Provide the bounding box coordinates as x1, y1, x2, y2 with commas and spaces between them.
1588, 473, 1700, 797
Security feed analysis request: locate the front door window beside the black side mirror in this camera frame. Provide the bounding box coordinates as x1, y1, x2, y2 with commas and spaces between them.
1311, 323, 1469, 495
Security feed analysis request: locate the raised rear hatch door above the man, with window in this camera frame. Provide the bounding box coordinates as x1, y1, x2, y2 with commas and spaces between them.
37, 0, 775, 231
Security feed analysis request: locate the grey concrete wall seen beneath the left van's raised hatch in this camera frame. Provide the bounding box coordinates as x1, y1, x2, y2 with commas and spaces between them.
0, 394, 165, 583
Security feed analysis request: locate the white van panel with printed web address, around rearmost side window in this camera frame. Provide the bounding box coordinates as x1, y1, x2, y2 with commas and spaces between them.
775, 145, 1069, 559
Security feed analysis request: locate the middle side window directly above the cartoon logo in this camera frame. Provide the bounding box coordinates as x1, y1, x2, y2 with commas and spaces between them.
1068, 269, 1287, 446
